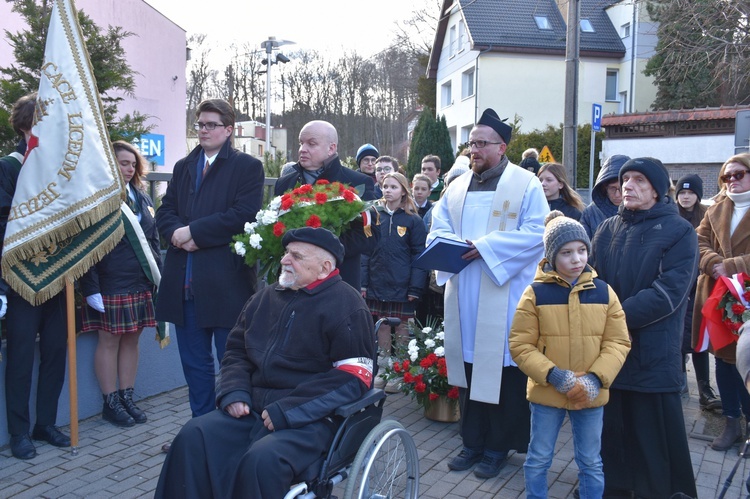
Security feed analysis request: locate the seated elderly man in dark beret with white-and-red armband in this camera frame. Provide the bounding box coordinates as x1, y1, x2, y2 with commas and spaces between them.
155, 227, 375, 498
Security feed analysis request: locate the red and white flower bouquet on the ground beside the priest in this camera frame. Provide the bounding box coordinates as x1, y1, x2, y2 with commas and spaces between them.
385, 319, 458, 409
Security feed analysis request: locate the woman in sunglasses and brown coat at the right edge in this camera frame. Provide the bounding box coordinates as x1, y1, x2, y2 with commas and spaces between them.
692, 154, 750, 450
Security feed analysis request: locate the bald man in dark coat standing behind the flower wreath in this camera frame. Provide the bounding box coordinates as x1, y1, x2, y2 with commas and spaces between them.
275, 121, 377, 290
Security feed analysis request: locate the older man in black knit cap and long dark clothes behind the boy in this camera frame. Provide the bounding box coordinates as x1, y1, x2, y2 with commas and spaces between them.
591, 158, 698, 498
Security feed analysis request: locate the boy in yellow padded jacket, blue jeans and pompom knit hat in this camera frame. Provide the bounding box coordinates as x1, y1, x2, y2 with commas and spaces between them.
509, 210, 630, 499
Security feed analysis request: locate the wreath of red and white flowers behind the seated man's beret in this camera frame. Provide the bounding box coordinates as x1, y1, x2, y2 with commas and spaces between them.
232, 179, 368, 281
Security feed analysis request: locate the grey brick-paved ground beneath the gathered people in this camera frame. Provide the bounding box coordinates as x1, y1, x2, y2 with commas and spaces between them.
0, 373, 750, 499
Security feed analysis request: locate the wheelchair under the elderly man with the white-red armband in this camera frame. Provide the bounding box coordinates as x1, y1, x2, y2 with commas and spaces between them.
284, 317, 419, 499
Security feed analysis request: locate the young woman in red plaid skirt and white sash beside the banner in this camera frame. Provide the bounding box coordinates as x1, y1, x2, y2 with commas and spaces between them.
79, 141, 161, 426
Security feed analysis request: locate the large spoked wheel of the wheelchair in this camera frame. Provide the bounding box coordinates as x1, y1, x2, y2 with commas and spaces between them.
344, 419, 419, 499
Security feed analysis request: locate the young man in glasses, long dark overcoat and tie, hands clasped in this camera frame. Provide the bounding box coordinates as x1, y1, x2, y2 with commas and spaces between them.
156, 99, 265, 428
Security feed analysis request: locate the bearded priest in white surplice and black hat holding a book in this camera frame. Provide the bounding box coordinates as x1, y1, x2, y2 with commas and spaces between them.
427, 109, 549, 478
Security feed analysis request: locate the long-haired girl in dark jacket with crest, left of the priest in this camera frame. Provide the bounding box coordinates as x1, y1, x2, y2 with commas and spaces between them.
362, 173, 427, 393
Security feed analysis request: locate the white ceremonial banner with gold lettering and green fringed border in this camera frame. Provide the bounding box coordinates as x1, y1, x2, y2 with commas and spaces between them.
2, 0, 124, 304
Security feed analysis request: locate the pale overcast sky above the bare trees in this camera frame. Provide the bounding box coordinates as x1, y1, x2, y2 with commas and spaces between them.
146, 0, 436, 57
